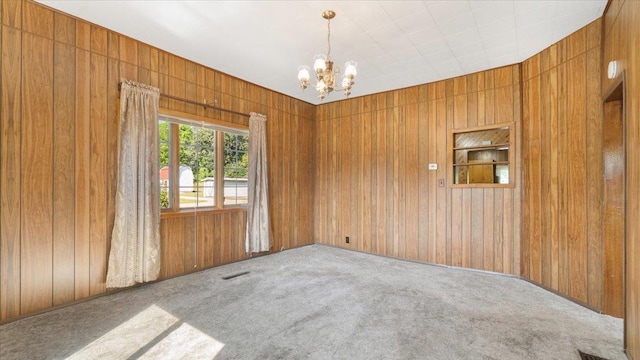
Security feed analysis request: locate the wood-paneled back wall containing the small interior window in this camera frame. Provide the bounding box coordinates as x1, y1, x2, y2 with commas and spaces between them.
314, 65, 522, 275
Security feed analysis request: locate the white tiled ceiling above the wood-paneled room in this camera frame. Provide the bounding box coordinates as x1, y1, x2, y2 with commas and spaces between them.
38, 0, 607, 104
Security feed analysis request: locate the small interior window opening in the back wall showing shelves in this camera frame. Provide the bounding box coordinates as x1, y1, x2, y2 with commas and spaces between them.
450, 124, 513, 187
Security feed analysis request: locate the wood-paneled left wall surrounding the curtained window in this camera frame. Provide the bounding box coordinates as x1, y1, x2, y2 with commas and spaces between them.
0, 0, 315, 321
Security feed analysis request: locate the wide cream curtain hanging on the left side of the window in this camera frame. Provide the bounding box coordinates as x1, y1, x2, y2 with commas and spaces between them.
107, 80, 160, 288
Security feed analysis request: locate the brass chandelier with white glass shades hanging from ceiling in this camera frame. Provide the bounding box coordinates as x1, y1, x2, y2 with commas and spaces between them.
298, 10, 358, 99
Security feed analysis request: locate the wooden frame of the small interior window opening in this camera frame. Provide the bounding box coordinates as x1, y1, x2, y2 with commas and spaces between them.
447, 122, 516, 188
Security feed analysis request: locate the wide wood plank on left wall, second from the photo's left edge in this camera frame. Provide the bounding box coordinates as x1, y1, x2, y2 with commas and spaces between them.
20, 33, 53, 313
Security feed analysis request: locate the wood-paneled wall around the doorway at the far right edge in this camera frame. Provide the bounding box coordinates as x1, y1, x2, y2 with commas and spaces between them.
602, 0, 640, 354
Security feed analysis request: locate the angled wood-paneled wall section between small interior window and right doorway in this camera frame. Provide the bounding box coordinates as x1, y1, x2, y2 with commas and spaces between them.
522, 20, 603, 309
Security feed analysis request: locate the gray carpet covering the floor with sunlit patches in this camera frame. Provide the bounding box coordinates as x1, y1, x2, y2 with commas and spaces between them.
0, 245, 626, 360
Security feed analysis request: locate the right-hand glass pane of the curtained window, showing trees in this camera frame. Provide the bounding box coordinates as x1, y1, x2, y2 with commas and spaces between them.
224, 133, 249, 205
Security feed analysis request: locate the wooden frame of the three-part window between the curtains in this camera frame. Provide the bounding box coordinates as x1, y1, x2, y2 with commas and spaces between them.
158, 108, 249, 218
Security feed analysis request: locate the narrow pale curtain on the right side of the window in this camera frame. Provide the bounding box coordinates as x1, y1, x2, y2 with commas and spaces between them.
246, 113, 271, 254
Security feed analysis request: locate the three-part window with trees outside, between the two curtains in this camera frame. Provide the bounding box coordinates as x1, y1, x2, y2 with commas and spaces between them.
159, 115, 249, 211
